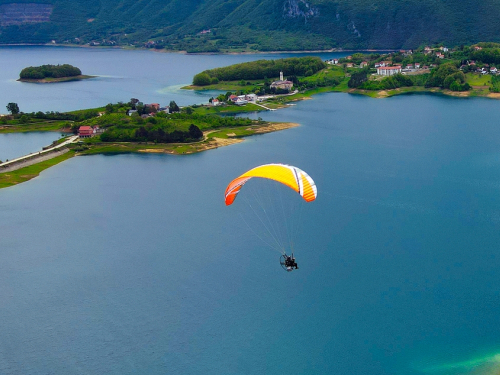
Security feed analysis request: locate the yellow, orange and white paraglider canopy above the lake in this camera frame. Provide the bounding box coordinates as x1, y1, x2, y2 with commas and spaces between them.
225, 164, 318, 206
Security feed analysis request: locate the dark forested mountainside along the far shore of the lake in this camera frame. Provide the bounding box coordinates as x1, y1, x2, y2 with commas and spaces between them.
0, 0, 500, 52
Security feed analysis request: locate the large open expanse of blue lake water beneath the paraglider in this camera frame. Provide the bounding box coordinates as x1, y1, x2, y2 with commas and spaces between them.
0, 50, 500, 375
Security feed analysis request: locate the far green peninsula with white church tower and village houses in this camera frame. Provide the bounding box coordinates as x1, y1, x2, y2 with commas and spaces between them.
185, 42, 500, 103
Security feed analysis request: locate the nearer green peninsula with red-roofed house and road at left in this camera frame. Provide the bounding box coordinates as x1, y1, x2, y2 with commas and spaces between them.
0, 98, 297, 189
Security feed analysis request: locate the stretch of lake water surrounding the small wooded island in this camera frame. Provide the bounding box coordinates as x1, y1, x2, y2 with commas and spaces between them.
0, 46, 348, 113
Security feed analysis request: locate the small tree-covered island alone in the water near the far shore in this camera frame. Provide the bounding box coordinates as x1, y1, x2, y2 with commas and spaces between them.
18, 64, 94, 83
